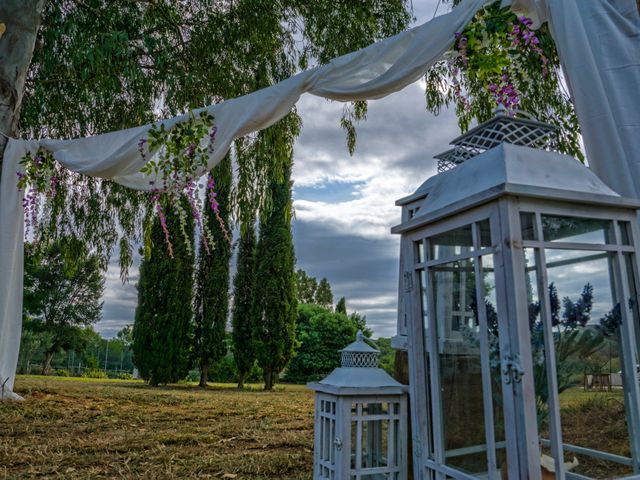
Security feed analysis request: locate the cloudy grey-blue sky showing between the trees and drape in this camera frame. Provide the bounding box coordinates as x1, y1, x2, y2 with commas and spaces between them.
96, 0, 459, 337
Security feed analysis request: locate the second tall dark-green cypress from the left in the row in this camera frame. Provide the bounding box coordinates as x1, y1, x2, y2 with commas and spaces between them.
193, 155, 232, 387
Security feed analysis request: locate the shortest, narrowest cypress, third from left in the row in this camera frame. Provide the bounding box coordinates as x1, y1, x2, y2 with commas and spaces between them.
231, 218, 257, 389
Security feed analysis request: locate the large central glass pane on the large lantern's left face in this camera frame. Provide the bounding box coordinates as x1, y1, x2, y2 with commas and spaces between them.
432, 259, 487, 473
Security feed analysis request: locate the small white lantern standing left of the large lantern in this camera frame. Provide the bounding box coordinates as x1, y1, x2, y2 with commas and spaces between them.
308, 332, 407, 480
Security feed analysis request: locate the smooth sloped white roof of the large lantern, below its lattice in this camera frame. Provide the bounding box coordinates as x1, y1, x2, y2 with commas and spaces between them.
392, 143, 640, 233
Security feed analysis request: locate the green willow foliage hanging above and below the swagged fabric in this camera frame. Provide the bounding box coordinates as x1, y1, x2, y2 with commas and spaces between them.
20, 0, 411, 280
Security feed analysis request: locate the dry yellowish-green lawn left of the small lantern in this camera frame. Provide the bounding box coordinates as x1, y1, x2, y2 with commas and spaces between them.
0, 376, 313, 479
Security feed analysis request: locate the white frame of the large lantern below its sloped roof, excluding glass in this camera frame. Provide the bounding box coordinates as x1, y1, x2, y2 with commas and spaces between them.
392, 142, 640, 480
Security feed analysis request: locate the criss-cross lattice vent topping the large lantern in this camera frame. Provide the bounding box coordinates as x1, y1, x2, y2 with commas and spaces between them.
435, 106, 558, 173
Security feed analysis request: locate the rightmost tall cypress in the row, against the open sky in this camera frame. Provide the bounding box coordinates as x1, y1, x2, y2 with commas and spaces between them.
254, 120, 297, 390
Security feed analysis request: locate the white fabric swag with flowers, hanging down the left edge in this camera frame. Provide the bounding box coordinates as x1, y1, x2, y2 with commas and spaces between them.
0, 0, 487, 398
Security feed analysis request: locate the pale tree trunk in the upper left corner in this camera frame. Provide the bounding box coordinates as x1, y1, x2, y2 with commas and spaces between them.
0, 0, 46, 180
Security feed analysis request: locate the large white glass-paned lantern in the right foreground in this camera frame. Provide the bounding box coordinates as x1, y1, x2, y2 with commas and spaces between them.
393, 110, 640, 480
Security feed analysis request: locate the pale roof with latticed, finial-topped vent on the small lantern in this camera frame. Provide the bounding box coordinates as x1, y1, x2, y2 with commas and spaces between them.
308, 331, 405, 395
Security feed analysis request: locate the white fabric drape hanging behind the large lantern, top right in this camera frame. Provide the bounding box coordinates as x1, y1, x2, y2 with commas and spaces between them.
511, 0, 640, 198
